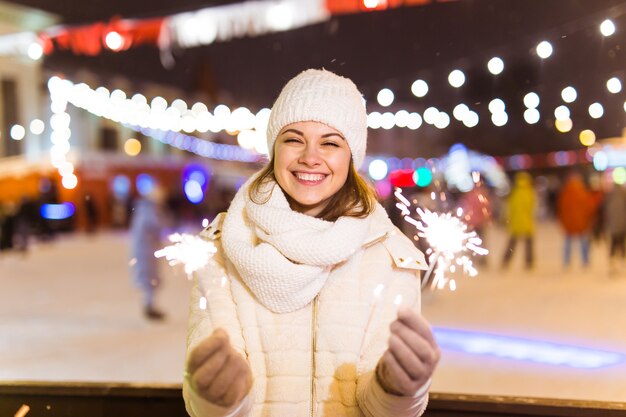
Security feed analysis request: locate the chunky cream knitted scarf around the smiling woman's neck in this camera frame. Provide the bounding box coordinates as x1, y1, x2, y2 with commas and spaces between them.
221, 180, 376, 313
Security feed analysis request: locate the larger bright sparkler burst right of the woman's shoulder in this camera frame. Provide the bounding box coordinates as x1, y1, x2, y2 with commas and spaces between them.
394, 188, 489, 291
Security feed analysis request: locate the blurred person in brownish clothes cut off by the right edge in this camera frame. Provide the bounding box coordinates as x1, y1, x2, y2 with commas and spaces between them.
602, 184, 626, 274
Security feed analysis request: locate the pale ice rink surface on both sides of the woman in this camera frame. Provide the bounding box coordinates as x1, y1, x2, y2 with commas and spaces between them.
0, 223, 626, 401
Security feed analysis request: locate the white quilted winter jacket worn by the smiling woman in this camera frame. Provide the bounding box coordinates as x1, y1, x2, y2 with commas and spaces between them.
183, 215, 428, 417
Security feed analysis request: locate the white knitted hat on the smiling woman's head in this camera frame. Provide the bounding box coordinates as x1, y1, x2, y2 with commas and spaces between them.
267, 69, 367, 169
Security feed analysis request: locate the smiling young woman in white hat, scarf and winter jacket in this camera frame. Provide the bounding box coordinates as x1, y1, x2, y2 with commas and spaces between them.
183, 70, 440, 417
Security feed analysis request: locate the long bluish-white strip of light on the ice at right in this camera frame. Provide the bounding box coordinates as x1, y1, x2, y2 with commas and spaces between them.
434, 328, 625, 368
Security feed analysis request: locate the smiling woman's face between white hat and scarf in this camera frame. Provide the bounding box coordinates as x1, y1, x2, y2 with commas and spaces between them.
274, 122, 351, 216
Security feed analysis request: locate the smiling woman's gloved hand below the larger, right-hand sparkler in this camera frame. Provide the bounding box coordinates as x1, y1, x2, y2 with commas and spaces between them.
376, 308, 441, 396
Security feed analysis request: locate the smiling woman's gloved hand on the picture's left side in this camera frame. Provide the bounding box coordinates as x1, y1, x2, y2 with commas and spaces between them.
187, 329, 252, 407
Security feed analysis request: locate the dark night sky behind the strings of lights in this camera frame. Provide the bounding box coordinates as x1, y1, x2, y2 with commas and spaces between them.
6, 0, 626, 157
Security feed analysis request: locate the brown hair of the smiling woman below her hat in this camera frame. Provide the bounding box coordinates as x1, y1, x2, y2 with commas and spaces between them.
248, 157, 376, 222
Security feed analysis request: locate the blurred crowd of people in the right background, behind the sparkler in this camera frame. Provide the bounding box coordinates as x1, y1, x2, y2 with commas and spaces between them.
386, 171, 626, 274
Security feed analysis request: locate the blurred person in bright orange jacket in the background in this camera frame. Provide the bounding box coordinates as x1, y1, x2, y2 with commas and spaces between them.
557, 172, 594, 267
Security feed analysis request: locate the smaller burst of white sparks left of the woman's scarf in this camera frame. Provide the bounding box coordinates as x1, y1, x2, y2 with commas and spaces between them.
154, 233, 217, 279
